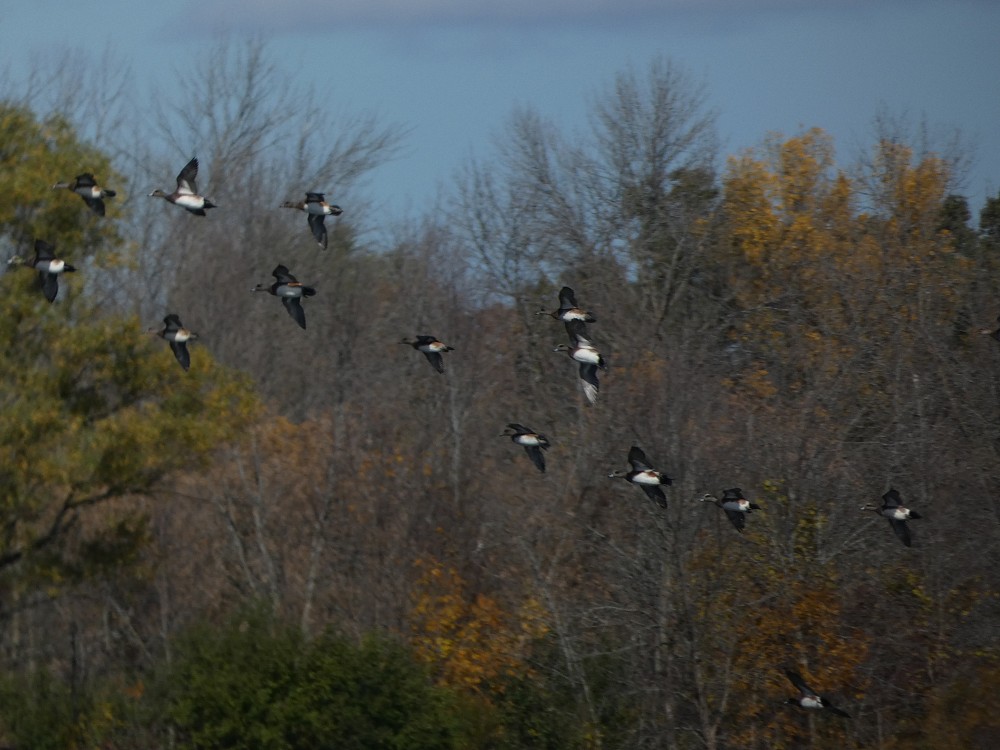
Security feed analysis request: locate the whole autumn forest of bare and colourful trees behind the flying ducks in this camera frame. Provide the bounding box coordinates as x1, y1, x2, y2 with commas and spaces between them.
0, 44, 1000, 750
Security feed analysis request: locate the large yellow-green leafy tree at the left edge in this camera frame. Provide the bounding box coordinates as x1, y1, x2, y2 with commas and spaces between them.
0, 100, 258, 712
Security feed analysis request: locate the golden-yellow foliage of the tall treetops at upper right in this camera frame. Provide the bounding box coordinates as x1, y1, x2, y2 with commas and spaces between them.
715, 129, 972, 412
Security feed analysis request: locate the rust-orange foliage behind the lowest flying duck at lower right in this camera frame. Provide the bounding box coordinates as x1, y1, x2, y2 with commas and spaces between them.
692, 482, 871, 748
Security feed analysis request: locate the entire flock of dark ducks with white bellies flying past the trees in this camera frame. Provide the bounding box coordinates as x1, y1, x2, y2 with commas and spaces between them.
9, 158, 928, 717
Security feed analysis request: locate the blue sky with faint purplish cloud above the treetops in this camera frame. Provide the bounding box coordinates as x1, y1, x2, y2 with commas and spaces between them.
0, 0, 1000, 220
